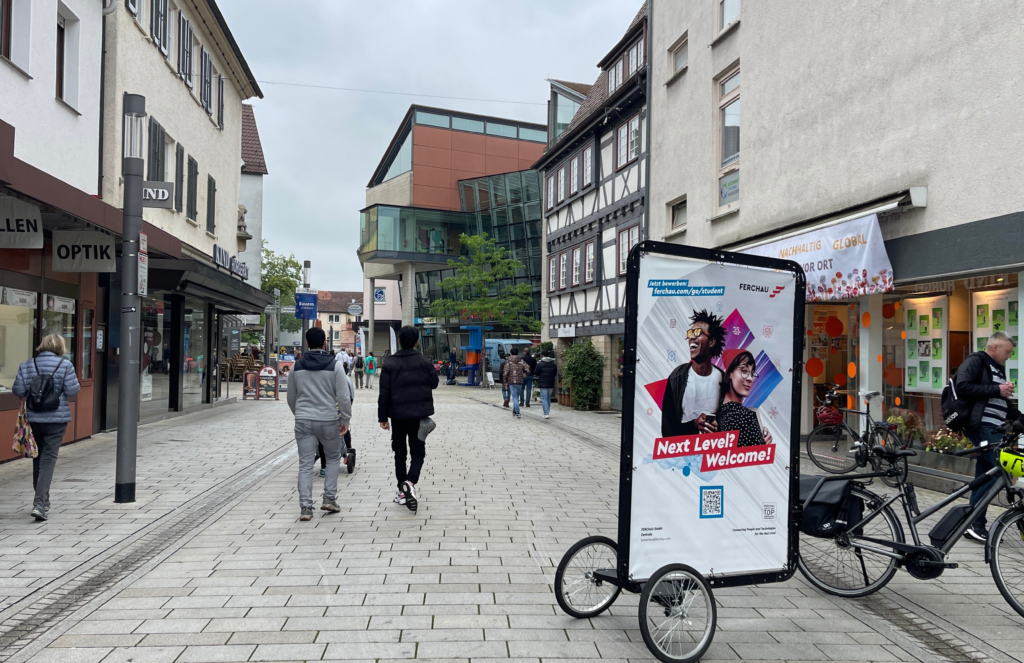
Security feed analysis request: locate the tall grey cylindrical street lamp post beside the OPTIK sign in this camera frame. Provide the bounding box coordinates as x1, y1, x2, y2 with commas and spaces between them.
114, 94, 145, 504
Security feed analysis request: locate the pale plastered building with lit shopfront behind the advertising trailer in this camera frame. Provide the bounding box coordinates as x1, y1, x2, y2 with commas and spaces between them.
650, 0, 1024, 467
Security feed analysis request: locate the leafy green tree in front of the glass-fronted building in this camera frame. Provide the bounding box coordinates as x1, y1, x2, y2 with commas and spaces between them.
430, 234, 541, 332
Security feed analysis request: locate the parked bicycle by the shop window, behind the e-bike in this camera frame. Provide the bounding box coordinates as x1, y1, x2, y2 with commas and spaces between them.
806, 385, 907, 488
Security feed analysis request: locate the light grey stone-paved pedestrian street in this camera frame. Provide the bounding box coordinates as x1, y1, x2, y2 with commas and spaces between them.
0, 387, 1024, 663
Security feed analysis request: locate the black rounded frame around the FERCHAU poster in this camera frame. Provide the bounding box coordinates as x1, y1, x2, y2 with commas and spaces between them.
616, 240, 807, 592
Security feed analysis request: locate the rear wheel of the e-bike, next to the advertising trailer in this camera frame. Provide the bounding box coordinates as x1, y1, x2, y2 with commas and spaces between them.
797, 487, 904, 598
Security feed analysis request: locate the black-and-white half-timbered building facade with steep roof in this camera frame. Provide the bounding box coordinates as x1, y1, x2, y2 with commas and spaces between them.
534, 5, 649, 409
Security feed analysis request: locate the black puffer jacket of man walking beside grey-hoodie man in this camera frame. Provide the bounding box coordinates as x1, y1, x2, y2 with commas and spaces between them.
377, 349, 437, 423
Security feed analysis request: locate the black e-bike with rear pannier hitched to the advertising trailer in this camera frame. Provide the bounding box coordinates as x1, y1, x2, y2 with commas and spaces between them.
797, 421, 1024, 617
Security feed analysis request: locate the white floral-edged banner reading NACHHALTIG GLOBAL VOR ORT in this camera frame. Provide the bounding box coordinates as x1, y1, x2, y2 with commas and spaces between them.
742, 214, 893, 301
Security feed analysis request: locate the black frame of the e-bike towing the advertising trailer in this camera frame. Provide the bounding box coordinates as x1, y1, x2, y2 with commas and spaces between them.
805, 466, 1022, 562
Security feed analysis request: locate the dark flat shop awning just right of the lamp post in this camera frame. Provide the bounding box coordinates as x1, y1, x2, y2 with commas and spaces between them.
150, 258, 273, 315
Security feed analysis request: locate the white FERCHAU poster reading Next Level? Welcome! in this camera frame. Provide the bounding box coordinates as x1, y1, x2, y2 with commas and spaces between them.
629, 254, 804, 580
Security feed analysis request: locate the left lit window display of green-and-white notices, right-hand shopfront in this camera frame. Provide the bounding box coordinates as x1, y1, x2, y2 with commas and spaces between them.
901, 295, 949, 393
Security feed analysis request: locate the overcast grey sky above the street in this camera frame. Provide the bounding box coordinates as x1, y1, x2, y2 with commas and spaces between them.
218, 0, 643, 290
